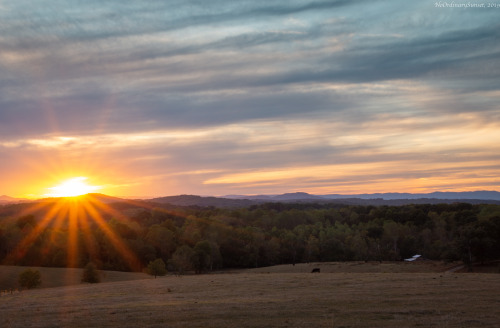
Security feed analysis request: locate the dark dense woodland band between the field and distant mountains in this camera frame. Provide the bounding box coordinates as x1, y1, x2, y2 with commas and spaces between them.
0, 197, 500, 273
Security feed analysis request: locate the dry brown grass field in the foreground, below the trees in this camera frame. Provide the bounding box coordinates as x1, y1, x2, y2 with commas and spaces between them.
0, 265, 500, 328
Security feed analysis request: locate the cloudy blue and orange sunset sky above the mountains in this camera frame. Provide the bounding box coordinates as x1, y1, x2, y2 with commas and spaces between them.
0, 0, 500, 198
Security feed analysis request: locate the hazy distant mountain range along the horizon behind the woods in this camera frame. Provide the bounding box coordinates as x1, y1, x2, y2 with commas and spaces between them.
0, 191, 500, 207
